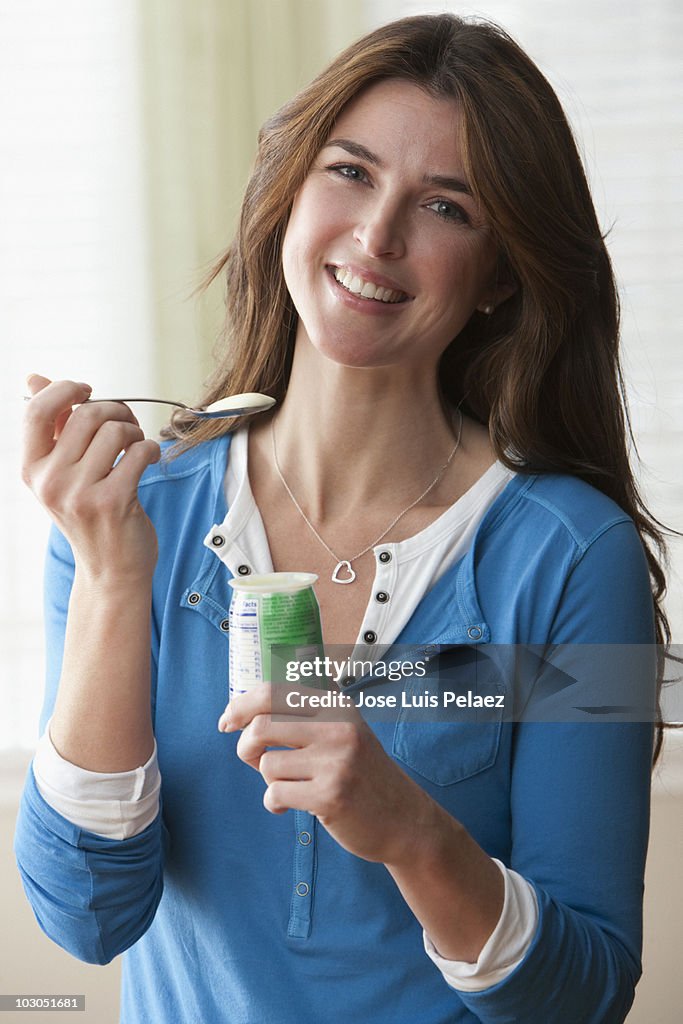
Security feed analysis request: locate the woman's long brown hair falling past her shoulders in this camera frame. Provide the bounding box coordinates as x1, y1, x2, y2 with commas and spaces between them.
165, 14, 671, 759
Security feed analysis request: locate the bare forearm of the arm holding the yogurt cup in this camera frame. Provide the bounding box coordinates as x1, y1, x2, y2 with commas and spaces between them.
386, 794, 505, 964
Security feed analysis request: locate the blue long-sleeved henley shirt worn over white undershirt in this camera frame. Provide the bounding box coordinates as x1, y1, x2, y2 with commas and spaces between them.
16, 437, 654, 1024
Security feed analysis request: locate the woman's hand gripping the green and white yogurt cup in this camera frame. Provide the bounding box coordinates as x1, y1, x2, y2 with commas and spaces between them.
218, 683, 440, 864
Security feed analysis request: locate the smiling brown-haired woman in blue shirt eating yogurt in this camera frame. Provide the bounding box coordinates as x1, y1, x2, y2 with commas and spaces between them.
17, 14, 667, 1024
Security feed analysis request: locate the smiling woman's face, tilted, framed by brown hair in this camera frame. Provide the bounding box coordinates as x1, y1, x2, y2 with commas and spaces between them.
283, 79, 505, 368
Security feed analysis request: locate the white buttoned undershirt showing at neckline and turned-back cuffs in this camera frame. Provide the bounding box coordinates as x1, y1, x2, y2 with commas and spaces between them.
33, 428, 539, 991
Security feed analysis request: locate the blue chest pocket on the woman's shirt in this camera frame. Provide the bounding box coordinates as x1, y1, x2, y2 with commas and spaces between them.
392, 648, 505, 785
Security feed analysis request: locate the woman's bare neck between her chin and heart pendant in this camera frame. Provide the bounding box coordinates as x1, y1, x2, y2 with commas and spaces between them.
252, 342, 466, 524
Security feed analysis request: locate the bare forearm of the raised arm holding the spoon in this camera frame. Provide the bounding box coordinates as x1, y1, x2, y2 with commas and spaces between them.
50, 570, 154, 772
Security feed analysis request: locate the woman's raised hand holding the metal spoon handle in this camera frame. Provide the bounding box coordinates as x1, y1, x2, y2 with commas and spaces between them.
22, 374, 161, 583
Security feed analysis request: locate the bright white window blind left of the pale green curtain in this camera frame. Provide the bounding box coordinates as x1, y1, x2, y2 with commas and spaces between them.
0, 0, 152, 749
